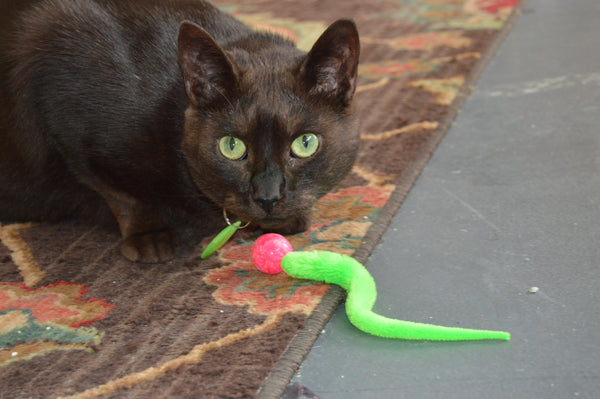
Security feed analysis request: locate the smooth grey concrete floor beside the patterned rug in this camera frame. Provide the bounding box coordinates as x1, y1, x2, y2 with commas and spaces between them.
295, 0, 600, 399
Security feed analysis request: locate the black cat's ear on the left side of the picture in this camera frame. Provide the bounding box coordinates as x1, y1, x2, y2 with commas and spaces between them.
177, 21, 237, 107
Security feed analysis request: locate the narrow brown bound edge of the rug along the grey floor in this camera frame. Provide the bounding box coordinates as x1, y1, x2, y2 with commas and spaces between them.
256, 0, 527, 399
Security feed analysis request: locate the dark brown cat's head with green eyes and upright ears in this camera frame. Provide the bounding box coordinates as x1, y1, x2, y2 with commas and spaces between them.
179, 20, 360, 233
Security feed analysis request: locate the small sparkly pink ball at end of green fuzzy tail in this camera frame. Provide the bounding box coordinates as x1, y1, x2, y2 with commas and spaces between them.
252, 233, 294, 274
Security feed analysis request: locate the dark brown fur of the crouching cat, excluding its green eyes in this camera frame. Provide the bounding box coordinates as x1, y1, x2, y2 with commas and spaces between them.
0, 0, 359, 262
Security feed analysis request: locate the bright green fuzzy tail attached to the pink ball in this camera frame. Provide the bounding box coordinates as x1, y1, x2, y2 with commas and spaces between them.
281, 251, 510, 341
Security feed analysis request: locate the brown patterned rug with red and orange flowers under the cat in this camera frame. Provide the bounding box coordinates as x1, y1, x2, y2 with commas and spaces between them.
0, 0, 518, 398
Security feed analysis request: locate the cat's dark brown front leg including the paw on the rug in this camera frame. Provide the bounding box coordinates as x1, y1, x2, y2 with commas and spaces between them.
101, 190, 178, 263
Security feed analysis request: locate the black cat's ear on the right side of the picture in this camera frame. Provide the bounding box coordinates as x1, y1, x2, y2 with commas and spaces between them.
301, 19, 360, 106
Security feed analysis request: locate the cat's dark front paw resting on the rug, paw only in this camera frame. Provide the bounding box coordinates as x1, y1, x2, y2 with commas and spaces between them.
121, 230, 178, 263
